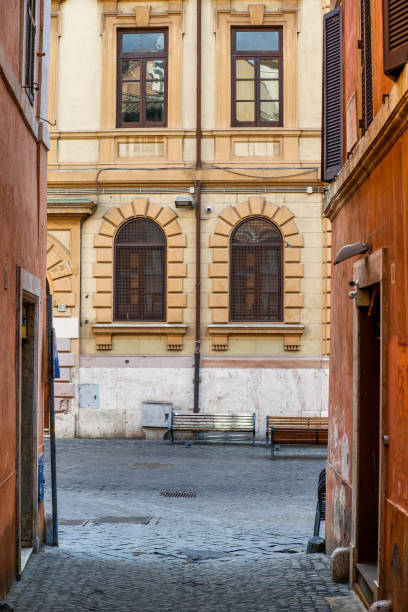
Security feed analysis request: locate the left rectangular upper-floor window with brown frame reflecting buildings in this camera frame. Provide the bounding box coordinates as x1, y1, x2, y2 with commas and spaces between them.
117, 30, 168, 127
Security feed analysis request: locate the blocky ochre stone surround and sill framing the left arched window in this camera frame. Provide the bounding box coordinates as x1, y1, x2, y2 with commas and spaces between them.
93, 198, 187, 350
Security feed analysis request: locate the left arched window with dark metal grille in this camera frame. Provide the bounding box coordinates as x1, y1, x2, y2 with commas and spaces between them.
114, 219, 166, 321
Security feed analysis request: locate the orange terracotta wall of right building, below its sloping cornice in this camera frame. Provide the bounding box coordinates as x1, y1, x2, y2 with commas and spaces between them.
326, 125, 408, 610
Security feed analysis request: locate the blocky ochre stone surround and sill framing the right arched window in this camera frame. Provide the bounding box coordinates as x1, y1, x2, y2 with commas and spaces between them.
208, 196, 303, 351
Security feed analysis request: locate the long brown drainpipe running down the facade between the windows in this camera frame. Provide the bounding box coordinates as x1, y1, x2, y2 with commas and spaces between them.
193, 0, 201, 412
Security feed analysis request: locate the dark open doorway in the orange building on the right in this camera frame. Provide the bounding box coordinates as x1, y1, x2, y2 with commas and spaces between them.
357, 284, 381, 604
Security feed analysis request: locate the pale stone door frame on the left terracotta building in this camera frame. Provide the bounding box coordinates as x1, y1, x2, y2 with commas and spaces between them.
16, 267, 41, 576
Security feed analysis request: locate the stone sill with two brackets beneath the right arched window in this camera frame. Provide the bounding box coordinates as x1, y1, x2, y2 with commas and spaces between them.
208, 322, 304, 351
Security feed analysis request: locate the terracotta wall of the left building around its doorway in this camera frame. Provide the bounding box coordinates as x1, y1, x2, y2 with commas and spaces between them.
0, 22, 46, 599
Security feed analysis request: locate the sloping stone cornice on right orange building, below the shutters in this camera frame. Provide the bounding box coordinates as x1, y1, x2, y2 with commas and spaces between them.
323, 66, 408, 221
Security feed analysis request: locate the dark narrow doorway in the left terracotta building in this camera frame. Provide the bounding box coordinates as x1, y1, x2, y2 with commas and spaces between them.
20, 297, 37, 565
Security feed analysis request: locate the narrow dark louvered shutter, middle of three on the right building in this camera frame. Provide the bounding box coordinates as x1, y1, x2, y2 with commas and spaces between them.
360, 0, 373, 133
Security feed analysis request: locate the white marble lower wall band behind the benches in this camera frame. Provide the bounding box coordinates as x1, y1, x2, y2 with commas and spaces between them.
57, 366, 329, 438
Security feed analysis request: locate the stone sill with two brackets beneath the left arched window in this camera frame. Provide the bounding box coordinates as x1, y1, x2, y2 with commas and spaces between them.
92, 321, 187, 351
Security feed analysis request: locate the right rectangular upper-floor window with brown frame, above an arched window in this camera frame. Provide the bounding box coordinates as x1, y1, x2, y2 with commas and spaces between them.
231, 28, 283, 127
